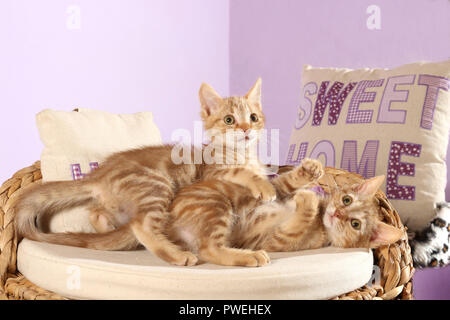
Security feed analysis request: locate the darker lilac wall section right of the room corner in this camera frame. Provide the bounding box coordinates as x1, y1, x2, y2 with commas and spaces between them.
230, 0, 450, 299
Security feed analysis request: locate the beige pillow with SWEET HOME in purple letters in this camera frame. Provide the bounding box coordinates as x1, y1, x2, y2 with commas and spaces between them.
287, 60, 450, 230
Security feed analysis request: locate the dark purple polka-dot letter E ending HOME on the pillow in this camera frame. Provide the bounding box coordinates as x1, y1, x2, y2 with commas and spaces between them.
386, 141, 422, 200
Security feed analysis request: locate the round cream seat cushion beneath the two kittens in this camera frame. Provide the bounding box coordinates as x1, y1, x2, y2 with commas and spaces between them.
17, 239, 373, 299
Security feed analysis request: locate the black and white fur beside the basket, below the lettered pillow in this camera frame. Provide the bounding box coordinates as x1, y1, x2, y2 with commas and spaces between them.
409, 202, 450, 268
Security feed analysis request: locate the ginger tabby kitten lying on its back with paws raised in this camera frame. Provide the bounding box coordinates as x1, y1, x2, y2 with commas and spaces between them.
168, 159, 403, 267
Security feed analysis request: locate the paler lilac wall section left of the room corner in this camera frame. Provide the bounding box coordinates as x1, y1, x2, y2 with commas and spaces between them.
0, 0, 229, 181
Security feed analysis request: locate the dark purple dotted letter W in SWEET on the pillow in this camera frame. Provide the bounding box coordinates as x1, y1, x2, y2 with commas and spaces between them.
312, 81, 357, 126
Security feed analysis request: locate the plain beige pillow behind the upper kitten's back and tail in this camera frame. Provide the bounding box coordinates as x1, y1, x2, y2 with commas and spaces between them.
36, 108, 162, 232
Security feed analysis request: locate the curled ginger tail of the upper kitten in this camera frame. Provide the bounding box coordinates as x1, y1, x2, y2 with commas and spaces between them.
15, 180, 138, 250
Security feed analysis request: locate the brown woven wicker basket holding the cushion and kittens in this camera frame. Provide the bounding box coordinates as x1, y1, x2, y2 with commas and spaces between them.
0, 161, 414, 300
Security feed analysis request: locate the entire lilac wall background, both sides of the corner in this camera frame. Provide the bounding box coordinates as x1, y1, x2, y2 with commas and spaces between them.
0, 0, 450, 299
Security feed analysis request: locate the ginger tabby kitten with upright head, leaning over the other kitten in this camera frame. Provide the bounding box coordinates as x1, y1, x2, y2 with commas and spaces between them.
15, 79, 276, 265
